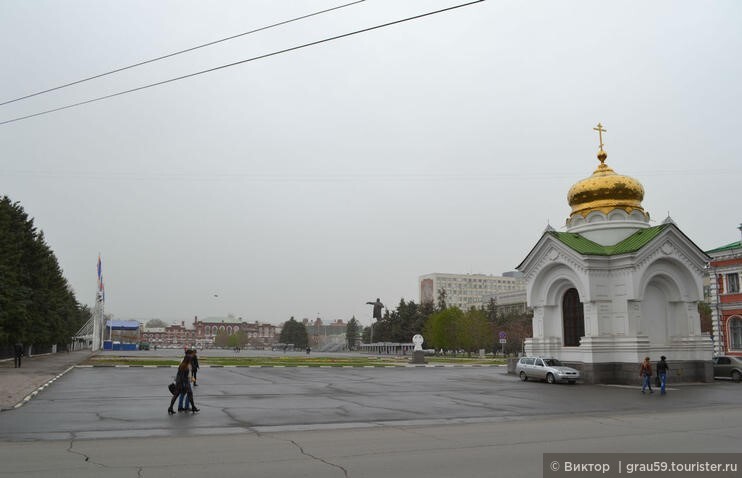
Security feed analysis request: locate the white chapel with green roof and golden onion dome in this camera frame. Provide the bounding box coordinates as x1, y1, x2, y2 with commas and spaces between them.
518, 124, 713, 383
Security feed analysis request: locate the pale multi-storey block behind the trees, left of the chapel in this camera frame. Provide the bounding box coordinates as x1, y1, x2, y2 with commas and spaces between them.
419, 271, 526, 310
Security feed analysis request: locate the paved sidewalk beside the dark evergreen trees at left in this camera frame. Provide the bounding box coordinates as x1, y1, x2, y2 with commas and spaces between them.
0, 350, 92, 410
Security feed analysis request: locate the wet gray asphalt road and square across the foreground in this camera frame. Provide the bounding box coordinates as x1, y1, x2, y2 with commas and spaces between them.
0, 367, 742, 477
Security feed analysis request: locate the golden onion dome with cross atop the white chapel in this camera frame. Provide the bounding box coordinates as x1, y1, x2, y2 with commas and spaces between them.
567, 123, 648, 219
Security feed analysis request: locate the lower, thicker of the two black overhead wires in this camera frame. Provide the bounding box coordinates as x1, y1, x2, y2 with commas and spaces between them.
0, 0, 484, 126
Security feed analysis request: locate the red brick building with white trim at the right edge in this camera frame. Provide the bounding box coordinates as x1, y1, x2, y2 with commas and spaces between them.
706, 224, 742, 356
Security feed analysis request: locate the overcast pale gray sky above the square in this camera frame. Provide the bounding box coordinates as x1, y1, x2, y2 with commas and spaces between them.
0, 0, 742, 324
